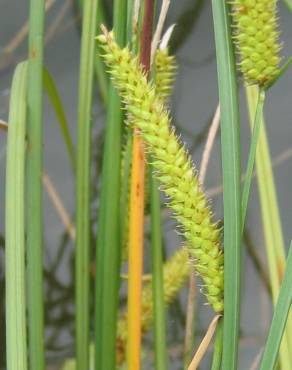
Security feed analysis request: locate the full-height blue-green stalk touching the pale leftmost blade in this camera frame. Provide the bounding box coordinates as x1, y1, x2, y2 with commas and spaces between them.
26, 0, 45, 370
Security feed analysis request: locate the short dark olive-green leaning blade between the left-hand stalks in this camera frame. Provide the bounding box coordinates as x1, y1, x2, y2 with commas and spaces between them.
43, 68, 75, 169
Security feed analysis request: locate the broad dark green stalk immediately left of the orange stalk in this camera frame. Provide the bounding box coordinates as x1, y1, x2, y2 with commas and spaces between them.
95, 0, 127, 370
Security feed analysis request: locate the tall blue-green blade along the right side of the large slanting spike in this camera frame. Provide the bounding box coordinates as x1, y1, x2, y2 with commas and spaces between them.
212, 0, 241, 370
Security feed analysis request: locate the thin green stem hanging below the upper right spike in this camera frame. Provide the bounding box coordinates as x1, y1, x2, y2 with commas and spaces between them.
241, 90, 265, 232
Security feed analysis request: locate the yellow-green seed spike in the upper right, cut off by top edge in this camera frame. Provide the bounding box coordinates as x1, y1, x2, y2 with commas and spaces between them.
230, 0, 281, 86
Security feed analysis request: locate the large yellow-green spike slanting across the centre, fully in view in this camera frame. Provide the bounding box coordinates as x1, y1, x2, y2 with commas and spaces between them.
98, 32, 224, 312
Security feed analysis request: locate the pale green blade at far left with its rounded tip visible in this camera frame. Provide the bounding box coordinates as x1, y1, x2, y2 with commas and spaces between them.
5, 62, 28, 370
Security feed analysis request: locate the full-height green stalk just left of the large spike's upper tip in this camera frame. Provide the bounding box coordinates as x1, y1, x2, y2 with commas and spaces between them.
75, 0, 98, 370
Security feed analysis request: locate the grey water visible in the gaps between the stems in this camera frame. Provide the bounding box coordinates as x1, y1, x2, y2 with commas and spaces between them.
0, 0, 292, 370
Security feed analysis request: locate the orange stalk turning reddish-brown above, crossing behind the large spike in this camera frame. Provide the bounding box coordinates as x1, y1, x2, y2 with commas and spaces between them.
127, 0, 154, 370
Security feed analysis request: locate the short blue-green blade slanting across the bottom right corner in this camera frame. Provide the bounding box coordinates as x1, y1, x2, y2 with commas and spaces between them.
260, 243, 292, 370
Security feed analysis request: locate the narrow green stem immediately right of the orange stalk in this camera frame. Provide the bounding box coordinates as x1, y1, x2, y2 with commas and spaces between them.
150, 173, 167, 370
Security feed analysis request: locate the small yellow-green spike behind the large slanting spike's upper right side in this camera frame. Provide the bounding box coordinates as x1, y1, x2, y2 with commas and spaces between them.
155, 49, 177, 100
